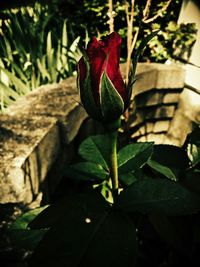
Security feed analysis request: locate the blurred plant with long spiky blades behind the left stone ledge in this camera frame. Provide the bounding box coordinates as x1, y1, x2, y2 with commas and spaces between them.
0, 3, 80, 110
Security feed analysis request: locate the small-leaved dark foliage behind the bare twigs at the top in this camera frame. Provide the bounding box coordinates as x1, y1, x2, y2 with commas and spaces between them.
53, 0, 194, 65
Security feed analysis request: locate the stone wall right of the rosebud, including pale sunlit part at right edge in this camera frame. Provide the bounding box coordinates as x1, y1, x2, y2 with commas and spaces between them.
126, 63, 200, 146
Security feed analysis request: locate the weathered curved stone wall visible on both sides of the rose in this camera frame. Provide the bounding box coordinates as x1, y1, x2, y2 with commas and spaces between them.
0, 63, 198, 204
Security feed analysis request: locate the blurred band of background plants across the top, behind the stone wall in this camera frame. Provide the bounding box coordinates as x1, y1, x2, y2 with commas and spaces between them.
0, 0, 197, 110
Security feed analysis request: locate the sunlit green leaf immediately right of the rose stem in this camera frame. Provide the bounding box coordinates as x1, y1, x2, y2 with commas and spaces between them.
118, 143, 153, 174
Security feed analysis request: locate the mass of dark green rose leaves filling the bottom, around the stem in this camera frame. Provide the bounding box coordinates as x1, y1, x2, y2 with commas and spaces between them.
11, 128, 200, 267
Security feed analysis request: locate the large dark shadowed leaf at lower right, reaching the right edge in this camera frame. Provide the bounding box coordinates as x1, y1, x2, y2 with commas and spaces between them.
116, 179, 200, 215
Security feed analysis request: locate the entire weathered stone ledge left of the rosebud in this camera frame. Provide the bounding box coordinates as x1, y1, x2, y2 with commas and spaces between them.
0, 77, 87, 204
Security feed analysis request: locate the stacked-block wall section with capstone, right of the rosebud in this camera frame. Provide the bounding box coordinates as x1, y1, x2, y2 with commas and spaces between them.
124, 63, 185, 143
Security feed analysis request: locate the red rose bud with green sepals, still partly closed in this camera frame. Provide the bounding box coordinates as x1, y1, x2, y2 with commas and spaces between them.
78, 32, 130, 122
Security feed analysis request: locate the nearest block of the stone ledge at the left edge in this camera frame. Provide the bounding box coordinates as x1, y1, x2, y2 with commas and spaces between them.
0, 115, 60, 203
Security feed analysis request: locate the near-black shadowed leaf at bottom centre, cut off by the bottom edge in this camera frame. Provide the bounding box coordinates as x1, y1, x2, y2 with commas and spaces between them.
81, 211, 136, 267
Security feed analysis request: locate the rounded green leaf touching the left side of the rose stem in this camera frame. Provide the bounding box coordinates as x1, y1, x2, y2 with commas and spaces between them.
78, 134, 110, 170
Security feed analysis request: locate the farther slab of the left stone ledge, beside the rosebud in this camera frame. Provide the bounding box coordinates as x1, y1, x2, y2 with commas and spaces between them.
7, 77, 87, 144
